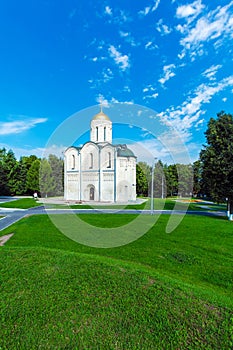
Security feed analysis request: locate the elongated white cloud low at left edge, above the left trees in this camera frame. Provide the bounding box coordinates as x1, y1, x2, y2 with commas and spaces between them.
0, 116, 47, 135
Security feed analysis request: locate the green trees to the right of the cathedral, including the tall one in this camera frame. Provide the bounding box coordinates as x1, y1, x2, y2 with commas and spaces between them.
137, 112, 233, 219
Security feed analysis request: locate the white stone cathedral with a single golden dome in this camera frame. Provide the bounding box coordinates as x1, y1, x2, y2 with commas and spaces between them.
64, 109, 136, 202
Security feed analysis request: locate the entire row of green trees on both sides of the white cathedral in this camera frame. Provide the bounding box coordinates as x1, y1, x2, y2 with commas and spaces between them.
0, 112, 233, 215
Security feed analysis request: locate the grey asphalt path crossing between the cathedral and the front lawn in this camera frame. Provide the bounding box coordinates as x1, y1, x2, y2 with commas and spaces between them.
0, 206, 226, 231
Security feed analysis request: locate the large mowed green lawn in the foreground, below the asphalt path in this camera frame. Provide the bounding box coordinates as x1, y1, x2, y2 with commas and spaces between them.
0, 214, 233, 349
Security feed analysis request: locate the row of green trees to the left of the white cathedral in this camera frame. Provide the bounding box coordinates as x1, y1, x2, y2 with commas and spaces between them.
0, 148, 64, 197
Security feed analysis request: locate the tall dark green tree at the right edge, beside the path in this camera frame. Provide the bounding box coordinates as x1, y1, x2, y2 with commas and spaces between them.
200, 112, 233, 215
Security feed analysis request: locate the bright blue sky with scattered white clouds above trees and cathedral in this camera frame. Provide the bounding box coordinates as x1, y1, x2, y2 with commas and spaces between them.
0, 0, 233, 161
